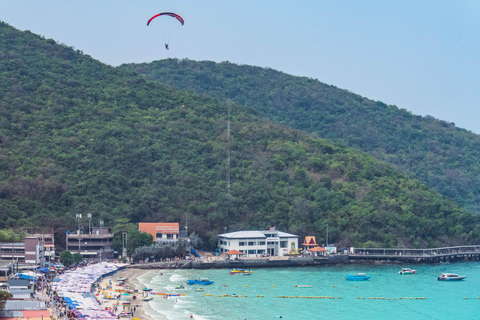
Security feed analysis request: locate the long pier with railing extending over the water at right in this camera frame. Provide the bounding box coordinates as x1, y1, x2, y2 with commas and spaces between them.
349, 245, 480, 263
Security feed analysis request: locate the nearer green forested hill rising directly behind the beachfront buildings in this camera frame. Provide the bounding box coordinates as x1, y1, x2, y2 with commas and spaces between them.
0, 23, 480, 248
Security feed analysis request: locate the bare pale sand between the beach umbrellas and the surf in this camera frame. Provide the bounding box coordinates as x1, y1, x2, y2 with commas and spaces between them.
95, 269, 155, 320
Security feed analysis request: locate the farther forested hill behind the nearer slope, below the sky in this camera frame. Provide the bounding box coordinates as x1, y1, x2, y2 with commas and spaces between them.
121, 59, 480, 212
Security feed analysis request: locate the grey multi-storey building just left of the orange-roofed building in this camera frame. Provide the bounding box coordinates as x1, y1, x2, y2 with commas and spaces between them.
66, 227, 114, 261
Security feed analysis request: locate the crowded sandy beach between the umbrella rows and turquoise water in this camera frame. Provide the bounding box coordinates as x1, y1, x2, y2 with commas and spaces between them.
95, 269, 154, 320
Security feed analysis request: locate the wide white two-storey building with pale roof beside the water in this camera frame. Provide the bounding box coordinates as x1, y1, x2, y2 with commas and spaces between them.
218, 231, 299, 257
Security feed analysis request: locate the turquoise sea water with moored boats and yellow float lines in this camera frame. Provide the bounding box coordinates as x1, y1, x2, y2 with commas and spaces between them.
138, 262, 480, 320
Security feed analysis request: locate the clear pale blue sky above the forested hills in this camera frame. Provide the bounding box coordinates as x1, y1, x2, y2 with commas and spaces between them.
0, 0, 480, 133
